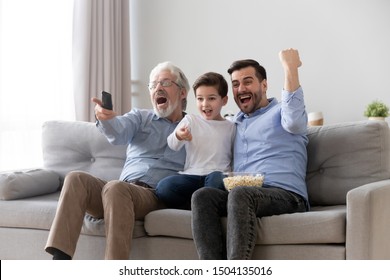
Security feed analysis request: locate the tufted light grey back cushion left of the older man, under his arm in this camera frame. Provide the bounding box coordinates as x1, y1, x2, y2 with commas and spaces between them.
42, 121, 127, 180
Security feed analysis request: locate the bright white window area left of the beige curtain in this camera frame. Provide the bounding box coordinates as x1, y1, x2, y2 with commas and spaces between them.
0, 0, 75, 171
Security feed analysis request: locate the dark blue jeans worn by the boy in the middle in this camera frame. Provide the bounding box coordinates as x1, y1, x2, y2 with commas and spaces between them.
156, 171, 225, 210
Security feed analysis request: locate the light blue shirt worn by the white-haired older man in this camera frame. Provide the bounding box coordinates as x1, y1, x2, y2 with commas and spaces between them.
97, 109, 185, 187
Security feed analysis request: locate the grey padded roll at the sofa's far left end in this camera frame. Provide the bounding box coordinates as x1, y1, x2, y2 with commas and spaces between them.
0, 169, 61, 200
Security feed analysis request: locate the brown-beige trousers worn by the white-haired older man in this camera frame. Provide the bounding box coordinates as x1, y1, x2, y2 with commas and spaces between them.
45, 171, 163, 259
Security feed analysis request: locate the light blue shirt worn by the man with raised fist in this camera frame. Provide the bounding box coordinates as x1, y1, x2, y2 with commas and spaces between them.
234, 87, 308, 200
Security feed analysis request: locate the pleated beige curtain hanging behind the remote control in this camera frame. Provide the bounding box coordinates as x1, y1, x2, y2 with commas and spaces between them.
73, 0, 131, 121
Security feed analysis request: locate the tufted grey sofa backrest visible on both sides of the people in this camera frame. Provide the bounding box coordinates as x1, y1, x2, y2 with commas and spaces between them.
42, 121, 390, 206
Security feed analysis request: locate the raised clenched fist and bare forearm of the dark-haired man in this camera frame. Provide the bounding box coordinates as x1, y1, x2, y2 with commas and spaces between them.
279, 49, 302, 92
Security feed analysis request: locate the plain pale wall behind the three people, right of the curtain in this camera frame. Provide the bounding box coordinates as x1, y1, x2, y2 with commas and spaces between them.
130, 0, 390, 124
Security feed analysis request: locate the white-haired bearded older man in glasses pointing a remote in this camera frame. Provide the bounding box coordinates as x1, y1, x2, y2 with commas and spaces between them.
45, 62, 189, 259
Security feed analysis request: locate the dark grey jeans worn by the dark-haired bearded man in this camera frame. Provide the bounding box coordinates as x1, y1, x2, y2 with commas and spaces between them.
192, 186, 307, 260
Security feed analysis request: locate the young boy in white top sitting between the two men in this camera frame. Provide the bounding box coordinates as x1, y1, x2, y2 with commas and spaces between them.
156, 72, 235, 209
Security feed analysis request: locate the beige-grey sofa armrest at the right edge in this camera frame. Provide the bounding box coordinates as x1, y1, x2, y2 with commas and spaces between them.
346, 180, 390, 260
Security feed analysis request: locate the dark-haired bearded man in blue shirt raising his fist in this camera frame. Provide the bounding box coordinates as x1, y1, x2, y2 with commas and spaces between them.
192, 49, 308, 259
